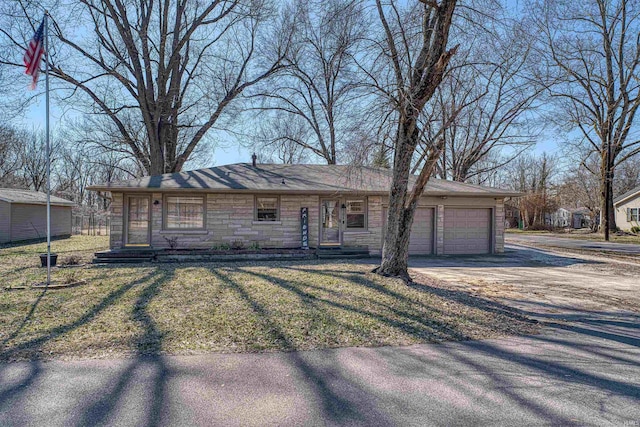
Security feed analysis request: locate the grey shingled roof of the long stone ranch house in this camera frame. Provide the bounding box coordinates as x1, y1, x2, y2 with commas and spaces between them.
88, 163, 520, 197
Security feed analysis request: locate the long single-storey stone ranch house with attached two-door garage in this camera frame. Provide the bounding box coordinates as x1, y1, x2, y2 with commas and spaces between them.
88, 163, 519, 254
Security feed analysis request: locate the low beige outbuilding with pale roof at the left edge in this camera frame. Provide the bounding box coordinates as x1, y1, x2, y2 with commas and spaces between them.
0, 188, 75, 243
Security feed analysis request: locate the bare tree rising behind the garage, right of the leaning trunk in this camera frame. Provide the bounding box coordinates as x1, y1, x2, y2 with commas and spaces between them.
414, 20, 541, 181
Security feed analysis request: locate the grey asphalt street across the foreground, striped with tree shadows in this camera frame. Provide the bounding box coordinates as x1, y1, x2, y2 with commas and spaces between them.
0, 324, 640, 426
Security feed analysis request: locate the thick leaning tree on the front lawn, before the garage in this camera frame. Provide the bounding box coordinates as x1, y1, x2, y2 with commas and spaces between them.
376, 0, 457, 281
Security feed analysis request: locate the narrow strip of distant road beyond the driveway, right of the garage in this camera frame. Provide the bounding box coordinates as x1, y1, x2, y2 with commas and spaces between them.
505, 233, 640, 255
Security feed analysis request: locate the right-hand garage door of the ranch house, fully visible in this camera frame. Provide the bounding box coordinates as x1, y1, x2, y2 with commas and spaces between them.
444, 208, 491, 254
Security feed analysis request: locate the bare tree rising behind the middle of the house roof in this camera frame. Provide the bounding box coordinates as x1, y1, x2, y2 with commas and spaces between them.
251, 0, 367, 164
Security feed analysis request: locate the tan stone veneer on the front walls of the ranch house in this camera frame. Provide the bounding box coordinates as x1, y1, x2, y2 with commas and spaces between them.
110, 193, 504, 255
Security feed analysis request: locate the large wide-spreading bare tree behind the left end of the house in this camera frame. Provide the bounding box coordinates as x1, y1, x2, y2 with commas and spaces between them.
0, 0, 293, 175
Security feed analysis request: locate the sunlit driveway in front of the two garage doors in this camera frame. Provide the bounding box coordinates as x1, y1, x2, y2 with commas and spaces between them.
410, 244, 640, 318
